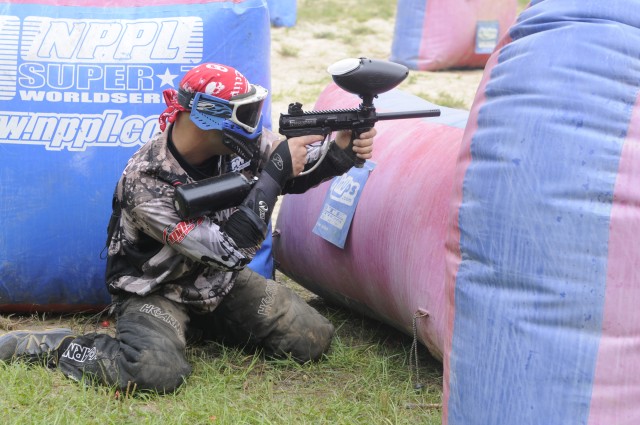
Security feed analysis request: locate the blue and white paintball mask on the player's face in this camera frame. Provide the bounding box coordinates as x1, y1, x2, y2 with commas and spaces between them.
178, 84, 269, 161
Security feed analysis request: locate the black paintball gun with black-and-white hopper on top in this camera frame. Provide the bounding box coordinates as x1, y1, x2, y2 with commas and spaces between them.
279, 58, 440, 175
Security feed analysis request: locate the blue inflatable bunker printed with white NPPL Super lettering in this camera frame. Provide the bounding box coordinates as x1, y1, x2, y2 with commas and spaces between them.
0, 0, 271, 312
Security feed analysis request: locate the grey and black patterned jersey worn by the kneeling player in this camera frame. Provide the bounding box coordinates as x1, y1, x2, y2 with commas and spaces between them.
106, 126, 353, 313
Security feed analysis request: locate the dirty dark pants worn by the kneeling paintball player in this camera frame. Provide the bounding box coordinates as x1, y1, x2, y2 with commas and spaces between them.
58, 269, 334, 392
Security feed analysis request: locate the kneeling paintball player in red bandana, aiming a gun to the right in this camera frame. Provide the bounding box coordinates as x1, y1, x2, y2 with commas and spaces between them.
0, 63, 376, 392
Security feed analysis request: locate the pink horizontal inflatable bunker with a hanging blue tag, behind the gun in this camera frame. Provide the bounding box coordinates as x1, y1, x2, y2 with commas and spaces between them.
274, 85, 468, 359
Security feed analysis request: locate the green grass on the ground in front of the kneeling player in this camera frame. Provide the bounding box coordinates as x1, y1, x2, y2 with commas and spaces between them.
0, 288, 442, 425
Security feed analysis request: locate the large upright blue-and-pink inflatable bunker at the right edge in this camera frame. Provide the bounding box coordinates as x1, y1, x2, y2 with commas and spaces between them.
443, 0, 640, 425
